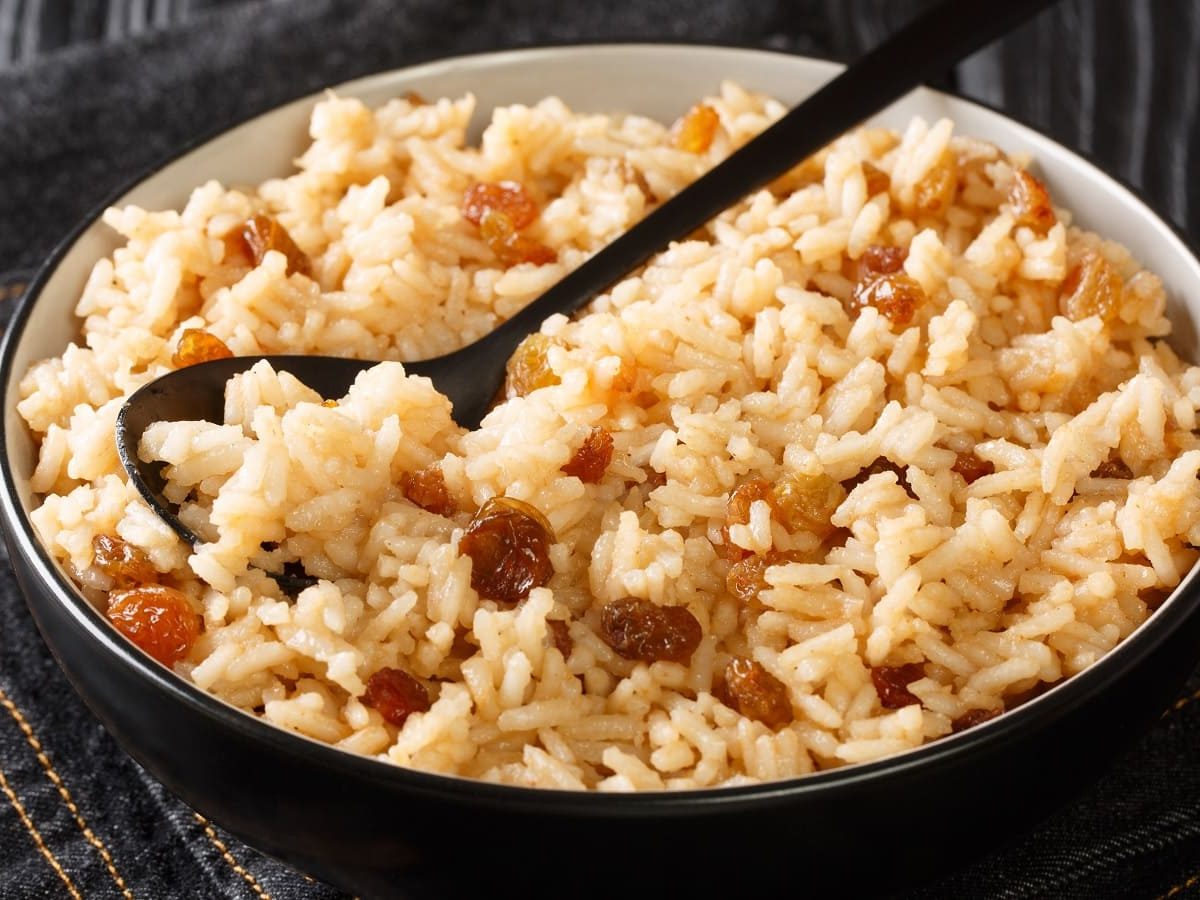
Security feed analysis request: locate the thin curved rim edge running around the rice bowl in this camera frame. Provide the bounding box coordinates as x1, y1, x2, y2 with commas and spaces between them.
0, 42, 1200, 830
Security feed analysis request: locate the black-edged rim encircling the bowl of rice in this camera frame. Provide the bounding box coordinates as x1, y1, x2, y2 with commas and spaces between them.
0, 40, 1200, 818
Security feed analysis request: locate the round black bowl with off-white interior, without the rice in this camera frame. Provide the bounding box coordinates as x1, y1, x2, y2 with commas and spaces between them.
0, 46, 1200, 896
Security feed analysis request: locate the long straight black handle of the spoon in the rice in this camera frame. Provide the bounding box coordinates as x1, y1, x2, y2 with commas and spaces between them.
472, 0, 1057, 359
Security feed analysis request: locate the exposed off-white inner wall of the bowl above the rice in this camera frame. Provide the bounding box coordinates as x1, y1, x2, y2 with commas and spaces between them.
5, 44, 1200, 600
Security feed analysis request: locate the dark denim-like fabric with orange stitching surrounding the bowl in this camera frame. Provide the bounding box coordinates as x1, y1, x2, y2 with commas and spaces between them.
0, 0, 1200, 900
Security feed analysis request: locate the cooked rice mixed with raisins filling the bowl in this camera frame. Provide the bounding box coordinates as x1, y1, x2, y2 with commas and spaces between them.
19, 85, 1200, 791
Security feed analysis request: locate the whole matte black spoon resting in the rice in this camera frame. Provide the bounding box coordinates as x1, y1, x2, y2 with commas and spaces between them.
116, 0, 1056, 566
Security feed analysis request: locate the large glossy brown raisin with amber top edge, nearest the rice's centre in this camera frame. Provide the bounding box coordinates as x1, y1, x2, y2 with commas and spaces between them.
458, 497, 554, 604
